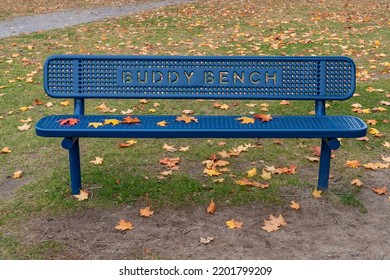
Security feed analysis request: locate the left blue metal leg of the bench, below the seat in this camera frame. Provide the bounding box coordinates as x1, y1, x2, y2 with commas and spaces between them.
62, 138, 81, 194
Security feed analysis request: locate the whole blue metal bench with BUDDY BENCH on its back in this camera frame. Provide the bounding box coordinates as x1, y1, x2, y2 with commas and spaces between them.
36, 55, 367, 194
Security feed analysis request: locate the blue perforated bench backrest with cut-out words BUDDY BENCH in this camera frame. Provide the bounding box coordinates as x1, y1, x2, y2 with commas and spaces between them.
44, 55, 355, 100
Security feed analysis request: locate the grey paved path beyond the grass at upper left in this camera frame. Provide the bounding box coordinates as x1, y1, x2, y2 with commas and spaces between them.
0, 0, 194, 38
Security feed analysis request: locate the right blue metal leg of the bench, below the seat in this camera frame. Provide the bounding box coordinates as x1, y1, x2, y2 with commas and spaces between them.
317, 138, 340, 190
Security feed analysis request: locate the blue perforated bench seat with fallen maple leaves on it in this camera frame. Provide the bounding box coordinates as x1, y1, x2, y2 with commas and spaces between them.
36, 115, 367, 138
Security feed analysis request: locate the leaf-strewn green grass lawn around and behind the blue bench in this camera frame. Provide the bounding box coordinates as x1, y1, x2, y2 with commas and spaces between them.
0, 0, 390, 259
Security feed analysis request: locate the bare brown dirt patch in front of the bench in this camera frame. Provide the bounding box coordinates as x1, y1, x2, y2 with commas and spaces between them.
25, 185, 390, 259
